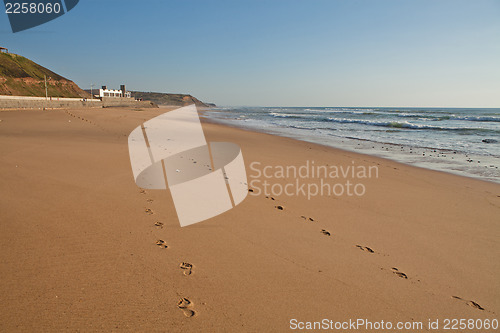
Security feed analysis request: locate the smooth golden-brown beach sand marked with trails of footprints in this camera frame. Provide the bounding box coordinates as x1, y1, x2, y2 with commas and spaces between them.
0, 109, 500, 332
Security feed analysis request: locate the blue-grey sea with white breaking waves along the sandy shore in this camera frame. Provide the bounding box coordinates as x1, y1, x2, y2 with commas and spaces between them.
204, 107, 500, 183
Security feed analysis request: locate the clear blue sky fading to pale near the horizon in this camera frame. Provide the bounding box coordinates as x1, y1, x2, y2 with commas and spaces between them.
0, 0, 500, 107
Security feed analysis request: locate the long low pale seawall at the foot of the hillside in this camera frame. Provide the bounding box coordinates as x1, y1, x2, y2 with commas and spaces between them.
0, 96, 158, 109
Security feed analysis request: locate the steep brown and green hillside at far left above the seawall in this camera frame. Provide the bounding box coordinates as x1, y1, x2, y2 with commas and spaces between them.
0, 53, 90, 98
